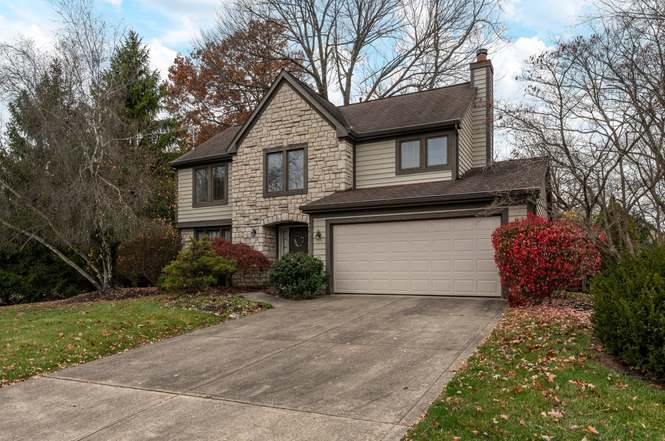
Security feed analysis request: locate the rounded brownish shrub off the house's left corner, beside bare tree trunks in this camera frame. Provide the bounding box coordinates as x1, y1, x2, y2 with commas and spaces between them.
115, 222, 182, 286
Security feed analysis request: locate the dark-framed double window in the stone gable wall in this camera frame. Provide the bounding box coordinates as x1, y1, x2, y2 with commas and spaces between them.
264, 145, 307, 196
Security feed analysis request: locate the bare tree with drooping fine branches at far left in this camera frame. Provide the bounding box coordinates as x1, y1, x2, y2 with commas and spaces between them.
0, 0, 160, 289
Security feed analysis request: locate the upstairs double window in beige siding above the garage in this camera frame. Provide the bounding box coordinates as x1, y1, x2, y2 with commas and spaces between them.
397, 134, 450, 174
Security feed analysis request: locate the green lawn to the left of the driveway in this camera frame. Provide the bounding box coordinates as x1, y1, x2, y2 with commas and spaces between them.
0, 296, 270, 386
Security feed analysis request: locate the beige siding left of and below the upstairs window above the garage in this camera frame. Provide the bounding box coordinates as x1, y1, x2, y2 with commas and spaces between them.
356, 139, 452, 188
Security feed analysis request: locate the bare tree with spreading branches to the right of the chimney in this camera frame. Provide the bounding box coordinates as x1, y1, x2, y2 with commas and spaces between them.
501, 0, 665, 256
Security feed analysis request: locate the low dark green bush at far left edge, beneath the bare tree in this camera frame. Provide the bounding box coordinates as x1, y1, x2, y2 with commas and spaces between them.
0, 245, 92, 305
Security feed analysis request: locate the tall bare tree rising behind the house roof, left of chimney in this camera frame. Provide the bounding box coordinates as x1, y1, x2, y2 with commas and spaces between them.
210, 0, 502, 104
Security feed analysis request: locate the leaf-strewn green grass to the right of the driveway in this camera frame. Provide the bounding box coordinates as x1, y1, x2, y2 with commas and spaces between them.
405, 307, 665, 441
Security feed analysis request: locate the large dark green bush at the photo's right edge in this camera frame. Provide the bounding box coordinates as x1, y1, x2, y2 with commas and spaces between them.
591, 247, 665, 378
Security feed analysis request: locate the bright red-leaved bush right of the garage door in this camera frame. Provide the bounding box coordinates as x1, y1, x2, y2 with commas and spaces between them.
492, 214, 601, 306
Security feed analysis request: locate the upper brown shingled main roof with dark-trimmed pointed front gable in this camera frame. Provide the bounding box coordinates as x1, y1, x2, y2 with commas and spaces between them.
171, 71, 476, 168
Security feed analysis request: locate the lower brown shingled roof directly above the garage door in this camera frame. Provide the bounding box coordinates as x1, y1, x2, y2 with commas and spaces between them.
300, 158, 548, 213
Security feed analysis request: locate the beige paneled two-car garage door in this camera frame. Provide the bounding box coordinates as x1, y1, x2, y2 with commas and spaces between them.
333, 216, 501, 296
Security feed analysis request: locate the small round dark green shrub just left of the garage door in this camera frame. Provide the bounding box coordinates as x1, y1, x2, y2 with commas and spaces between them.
270, 253, 325, 299
